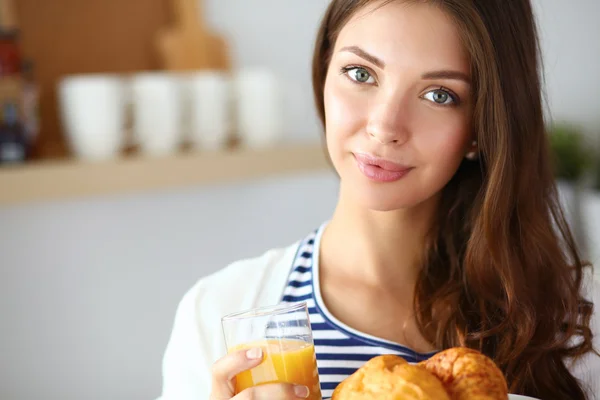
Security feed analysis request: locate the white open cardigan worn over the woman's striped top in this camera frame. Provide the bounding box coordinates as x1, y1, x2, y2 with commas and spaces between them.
158, 242, 600, 400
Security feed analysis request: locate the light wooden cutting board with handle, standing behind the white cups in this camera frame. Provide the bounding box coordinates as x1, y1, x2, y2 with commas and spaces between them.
156, 0, 231, 71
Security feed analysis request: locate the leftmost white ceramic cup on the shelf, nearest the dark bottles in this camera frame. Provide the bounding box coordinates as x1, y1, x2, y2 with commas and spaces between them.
58, 75, 126, 161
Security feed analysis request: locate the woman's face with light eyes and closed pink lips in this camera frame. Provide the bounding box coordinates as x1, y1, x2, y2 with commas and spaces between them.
324, 1, 474, 211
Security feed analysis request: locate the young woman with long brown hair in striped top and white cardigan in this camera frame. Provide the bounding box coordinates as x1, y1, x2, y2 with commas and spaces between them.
163, 0, 600, 400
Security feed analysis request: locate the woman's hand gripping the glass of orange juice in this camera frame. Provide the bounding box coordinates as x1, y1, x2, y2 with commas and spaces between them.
210, 348, 309, 400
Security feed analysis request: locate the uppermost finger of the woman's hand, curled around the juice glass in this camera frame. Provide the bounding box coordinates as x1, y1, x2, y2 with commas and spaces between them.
212, 348, 263, 399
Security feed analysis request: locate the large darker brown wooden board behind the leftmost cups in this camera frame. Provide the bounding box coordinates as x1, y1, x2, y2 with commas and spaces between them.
15, 0, 173, 159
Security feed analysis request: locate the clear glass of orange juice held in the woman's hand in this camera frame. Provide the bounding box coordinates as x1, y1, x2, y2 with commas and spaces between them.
222, 303, 321, 400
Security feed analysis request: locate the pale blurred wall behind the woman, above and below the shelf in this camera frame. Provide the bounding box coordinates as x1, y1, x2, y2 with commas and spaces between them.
0, 0, 600, 400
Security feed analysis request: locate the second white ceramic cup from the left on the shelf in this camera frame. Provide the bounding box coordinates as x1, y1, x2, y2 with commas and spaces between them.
130, 73, 183, 156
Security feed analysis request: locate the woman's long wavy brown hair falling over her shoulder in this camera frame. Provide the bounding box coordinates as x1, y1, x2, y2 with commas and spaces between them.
313, 0, 594, 400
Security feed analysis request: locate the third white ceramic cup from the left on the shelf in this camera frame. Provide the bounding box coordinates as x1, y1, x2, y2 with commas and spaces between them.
185, 71, 232, 150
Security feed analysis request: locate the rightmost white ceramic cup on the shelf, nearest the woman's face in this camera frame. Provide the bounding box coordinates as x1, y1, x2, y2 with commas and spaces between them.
235, 69, 283, 148
